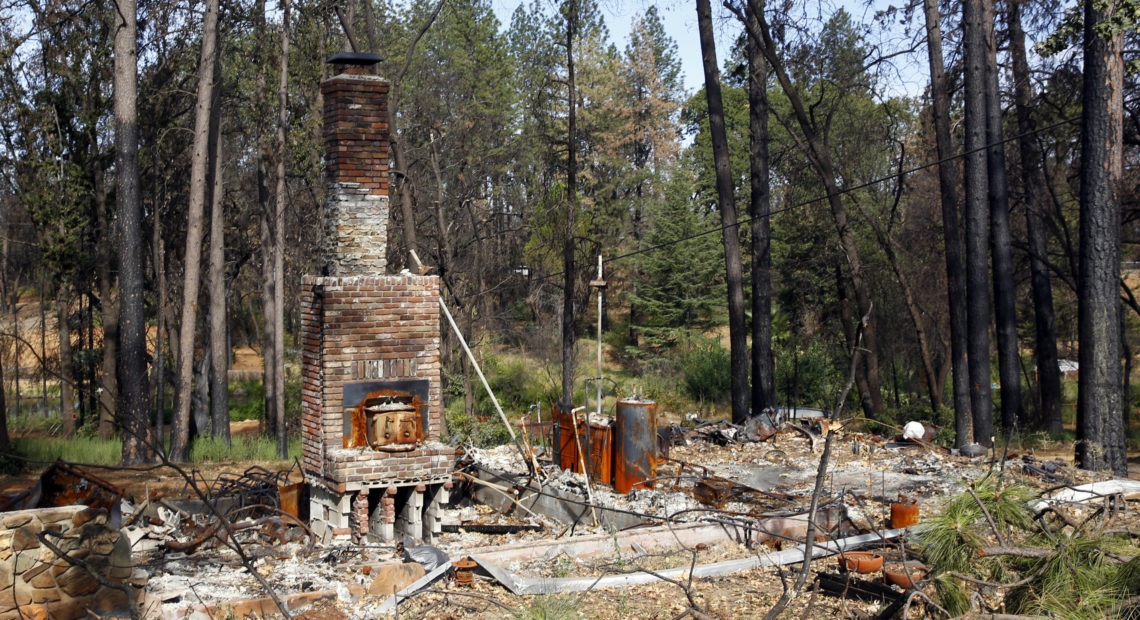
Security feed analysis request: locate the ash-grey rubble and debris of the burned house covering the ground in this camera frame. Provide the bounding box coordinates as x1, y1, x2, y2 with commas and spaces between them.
0, 418, 1140, 618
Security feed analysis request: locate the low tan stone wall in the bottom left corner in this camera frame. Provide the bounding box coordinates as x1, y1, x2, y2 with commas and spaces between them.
0, 506, 132, 620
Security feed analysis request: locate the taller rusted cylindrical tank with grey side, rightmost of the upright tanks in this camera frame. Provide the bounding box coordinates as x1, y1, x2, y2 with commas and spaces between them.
613, 399, 657, 493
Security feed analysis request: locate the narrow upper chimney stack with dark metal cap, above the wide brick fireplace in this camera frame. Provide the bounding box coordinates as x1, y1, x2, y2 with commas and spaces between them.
320, 54, 389, 276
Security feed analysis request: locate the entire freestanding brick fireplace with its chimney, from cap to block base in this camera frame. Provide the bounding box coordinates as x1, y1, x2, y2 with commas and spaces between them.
301, 55, 455, 543
